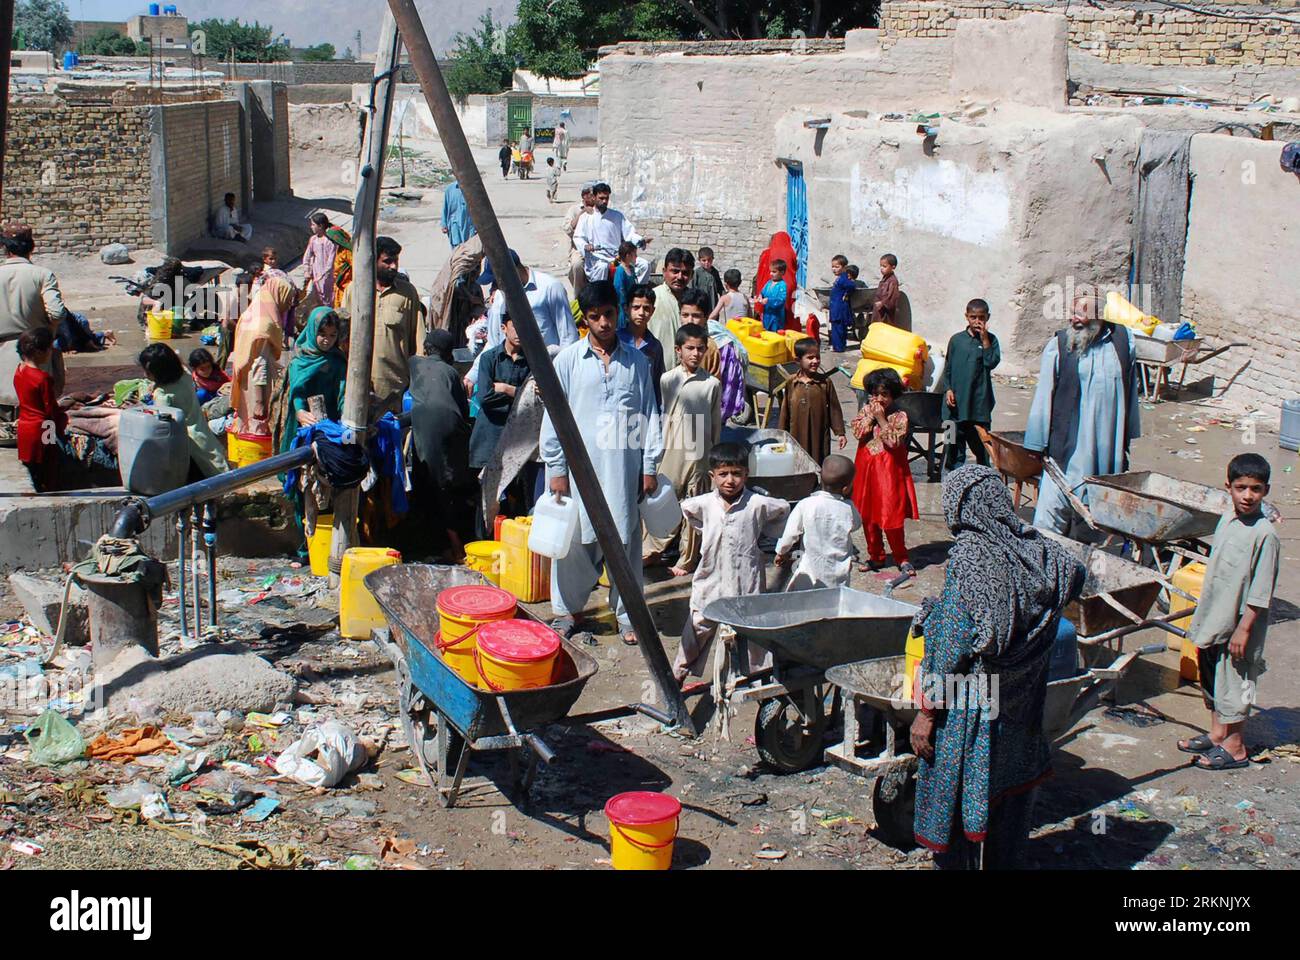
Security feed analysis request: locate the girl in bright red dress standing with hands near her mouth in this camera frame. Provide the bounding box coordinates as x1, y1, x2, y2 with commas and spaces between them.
853, 368, 920, 576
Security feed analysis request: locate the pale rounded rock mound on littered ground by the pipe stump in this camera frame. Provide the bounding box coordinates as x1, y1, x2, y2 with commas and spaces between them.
95, 644, 298, 715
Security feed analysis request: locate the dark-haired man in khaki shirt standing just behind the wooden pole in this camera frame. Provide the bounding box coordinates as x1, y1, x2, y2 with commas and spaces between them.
339, 237, 424, 415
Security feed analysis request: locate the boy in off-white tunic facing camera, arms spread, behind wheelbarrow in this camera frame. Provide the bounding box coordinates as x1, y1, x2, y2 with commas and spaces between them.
672, 444, 790, 683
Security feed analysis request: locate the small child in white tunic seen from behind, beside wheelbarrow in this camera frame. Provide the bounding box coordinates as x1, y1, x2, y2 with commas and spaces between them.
776, 454, 862, 591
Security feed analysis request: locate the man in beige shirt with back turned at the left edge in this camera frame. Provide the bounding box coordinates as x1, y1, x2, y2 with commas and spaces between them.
0, 222, 72, 421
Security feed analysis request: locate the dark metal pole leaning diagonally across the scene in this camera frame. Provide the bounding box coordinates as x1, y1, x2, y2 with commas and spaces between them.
384, 0, 694, 732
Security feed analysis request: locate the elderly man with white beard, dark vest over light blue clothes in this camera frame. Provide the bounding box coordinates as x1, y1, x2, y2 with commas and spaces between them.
1024, 295, 1141, 536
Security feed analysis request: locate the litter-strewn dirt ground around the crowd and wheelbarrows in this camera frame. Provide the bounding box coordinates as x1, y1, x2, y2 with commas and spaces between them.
0, 130, 1300, 870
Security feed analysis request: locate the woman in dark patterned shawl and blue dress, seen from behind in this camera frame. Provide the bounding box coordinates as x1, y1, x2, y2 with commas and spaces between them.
911, 464, 1084, 869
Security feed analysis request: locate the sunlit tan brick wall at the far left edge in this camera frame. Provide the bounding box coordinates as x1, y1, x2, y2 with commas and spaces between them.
4, 103, 151, 252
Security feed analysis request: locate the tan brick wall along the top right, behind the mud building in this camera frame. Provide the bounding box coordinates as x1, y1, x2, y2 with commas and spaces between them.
880, 0, 1300, 66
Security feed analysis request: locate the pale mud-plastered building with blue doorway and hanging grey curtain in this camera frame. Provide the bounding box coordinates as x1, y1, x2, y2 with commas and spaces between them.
599, 13, 1300, 416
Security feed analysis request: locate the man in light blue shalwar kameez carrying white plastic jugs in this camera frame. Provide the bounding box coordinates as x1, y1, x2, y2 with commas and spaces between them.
540, 280, 663, 644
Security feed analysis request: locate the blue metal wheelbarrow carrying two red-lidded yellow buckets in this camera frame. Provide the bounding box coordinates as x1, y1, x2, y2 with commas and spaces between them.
365, 563, 597, 807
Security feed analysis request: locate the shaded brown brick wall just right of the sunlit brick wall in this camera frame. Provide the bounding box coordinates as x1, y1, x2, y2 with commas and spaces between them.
157, 100, 244, 251
